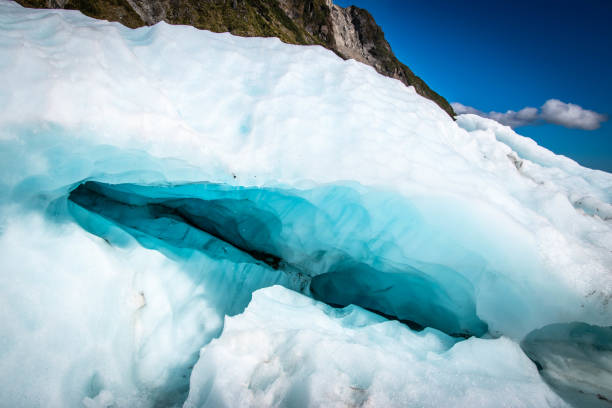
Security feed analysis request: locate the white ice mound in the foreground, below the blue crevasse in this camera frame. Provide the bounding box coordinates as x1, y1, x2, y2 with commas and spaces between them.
185, 286, 565, 407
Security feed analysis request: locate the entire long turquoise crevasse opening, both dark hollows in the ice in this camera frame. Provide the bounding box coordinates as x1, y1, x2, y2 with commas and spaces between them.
68, 181, 487, 337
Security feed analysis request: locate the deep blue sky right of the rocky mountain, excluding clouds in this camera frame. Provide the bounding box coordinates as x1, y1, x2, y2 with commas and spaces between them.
335, 0, 612, 172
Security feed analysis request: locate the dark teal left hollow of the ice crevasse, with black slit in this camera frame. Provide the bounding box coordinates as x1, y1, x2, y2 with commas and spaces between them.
69, 181, 281, 269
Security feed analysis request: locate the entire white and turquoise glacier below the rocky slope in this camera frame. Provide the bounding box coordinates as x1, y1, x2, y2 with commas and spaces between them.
0, 0, 612, 407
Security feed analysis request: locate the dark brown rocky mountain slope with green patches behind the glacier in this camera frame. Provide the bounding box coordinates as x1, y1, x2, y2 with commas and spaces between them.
16, 0, 455, 117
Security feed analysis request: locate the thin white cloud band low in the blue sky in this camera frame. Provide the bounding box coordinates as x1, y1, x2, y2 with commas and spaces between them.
451, 99, 608, 130
